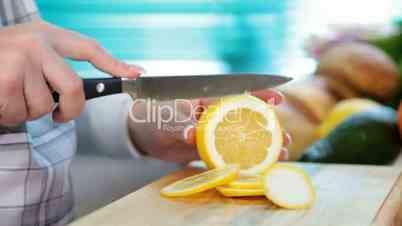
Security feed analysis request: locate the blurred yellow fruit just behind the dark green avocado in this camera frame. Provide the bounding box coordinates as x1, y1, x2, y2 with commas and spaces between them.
317, 98, 380, 138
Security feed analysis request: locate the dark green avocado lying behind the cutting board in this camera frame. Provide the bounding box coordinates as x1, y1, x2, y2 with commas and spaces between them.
300, 106, 400, 165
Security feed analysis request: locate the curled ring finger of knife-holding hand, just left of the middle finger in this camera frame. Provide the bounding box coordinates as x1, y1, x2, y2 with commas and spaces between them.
24, 61, 54, 120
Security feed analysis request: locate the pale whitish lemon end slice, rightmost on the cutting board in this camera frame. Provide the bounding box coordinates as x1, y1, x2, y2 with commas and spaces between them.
264, 163, 316, 209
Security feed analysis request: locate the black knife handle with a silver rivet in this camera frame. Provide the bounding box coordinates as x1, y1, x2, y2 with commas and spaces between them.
52, 78, 123, 103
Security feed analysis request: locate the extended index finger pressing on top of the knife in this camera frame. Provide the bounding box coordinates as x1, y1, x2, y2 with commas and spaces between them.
48, 28, 144, 78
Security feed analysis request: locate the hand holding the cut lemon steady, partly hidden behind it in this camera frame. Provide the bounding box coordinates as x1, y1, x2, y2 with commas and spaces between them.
129, 90, 291, 163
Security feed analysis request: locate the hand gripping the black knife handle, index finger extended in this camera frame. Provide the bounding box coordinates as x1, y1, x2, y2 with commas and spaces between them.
0, 20, 142, 125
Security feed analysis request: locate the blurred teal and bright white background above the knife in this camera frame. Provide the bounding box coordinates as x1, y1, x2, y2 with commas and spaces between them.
38, 0, 401, 77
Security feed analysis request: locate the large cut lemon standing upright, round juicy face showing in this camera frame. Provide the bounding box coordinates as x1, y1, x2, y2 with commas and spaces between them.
196, 95, 283, 175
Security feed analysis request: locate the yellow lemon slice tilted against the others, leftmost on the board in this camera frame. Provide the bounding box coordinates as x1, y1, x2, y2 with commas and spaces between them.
161, 165, 239, 197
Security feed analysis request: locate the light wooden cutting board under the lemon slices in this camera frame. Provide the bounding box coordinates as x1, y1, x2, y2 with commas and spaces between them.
71, 164, 402, 226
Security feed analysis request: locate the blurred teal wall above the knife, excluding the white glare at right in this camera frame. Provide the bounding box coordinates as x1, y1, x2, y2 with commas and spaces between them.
37, 0, 290, 76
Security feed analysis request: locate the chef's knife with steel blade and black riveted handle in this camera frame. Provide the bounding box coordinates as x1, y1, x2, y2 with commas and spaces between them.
53, 73, 292, 102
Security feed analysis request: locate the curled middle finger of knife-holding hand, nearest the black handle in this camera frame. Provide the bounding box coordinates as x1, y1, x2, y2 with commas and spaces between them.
41, 48, 85, 122
